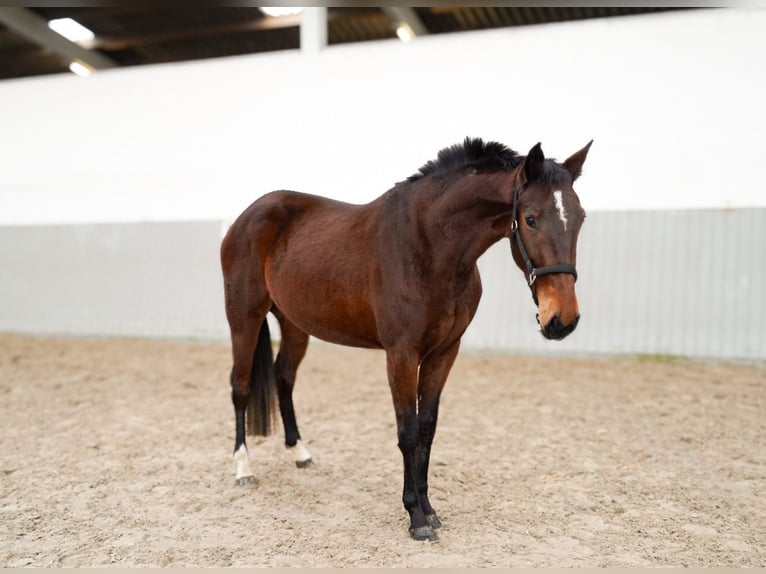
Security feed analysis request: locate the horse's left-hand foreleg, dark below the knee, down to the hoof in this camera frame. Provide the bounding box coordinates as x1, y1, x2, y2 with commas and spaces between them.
386, 351, 436, 540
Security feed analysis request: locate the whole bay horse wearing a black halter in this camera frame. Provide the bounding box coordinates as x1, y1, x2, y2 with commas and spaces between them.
221, 138, 593, 540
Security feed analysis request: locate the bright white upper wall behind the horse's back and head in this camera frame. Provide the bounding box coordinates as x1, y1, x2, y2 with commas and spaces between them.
0, 9, 766, 224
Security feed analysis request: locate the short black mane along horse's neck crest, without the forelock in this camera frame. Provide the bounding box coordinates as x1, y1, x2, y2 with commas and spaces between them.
407, 137, 524, 181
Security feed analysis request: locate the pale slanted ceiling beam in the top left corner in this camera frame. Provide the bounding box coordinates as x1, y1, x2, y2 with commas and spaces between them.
0, 6, 118, 70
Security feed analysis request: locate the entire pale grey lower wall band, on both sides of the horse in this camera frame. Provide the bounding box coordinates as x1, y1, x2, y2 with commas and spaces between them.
0, 209, 766, 359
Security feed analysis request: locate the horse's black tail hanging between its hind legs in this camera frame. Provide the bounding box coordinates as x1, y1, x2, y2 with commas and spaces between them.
247, 317, 277, 436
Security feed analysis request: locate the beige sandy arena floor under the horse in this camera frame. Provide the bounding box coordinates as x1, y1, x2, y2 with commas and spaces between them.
0, 335, 766, 567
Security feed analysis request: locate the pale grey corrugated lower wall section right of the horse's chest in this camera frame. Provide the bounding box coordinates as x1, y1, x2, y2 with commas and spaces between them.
464, 209, 766, 359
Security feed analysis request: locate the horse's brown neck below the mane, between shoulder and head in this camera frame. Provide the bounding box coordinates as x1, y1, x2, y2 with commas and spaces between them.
416, 171, 516, 268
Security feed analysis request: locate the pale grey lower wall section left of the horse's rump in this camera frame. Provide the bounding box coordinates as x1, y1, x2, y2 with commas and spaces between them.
0, 221, 231, 338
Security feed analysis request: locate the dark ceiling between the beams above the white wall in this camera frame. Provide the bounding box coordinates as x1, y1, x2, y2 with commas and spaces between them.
0, 4, 688, 79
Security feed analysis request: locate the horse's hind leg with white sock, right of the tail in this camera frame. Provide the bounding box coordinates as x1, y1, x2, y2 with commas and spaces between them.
272, 308, 313, 468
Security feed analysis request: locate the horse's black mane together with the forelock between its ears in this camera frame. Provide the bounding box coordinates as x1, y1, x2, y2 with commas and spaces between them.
407, 137, 571, 185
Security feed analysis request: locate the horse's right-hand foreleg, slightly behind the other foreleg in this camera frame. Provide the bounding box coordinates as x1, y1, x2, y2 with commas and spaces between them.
416, 341, 460, 529
